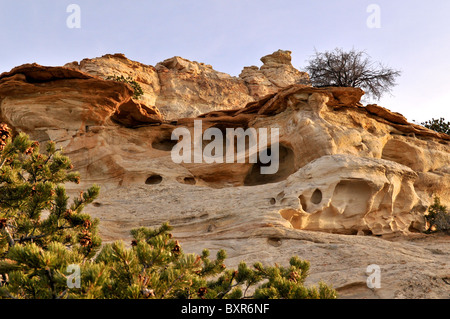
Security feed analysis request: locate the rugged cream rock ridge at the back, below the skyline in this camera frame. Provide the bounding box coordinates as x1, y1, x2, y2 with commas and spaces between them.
65, 50, 309, 121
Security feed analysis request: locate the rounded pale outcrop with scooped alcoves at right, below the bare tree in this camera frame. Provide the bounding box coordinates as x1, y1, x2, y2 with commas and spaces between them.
280, 155, 424, 235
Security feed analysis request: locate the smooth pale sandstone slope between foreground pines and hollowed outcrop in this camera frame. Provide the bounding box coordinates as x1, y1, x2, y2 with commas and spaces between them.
87, 181, 450, 299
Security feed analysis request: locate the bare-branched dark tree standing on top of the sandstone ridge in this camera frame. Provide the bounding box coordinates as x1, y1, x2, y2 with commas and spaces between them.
306, 48, 401, 100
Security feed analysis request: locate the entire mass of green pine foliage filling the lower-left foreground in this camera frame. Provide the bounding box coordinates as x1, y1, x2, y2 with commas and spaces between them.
0, 125, 336, 299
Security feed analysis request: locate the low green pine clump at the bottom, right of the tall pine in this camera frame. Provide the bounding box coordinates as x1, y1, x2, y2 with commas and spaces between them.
95, 223, 226, 299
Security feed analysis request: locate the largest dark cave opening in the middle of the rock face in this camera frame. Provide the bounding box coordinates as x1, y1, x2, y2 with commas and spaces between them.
244, 144, 295, 186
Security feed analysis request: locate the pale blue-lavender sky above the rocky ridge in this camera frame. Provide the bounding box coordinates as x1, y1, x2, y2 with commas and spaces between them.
0, 0, 450, 122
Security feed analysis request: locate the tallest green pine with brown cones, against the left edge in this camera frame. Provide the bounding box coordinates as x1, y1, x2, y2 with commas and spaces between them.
0, 124, 101, 298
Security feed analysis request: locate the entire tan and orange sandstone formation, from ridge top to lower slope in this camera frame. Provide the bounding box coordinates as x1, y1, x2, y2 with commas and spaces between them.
0, 51, 450, 298
